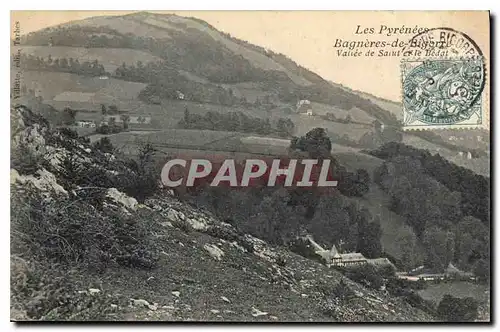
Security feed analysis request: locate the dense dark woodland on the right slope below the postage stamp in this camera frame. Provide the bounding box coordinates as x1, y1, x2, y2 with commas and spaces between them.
372, 143, 490, 276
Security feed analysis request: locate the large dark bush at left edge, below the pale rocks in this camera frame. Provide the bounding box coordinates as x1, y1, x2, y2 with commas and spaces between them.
11, 189, 158, 271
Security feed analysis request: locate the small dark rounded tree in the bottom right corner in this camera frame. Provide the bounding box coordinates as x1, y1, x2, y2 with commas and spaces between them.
437, 294, 478, 322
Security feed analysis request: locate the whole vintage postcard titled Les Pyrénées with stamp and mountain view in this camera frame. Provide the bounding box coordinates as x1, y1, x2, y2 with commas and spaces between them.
9, 11, 491, 323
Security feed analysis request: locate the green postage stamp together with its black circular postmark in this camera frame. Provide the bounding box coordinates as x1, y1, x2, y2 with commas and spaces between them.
403, 28, 485, 124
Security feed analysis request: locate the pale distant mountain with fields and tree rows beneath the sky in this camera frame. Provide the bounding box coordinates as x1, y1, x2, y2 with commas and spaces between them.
12, 12, 489, 174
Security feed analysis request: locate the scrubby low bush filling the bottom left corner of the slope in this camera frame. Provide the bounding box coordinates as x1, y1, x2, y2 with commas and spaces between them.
10, 256, 126, 321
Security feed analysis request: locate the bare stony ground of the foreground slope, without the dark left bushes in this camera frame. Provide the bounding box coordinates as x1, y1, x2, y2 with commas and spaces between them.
11, 107, 434, 322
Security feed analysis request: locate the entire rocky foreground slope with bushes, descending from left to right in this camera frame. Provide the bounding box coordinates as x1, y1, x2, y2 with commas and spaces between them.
11, 107, 434, 322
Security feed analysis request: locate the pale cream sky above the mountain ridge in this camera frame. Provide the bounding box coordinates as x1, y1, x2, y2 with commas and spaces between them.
11, 11, 489, 101
